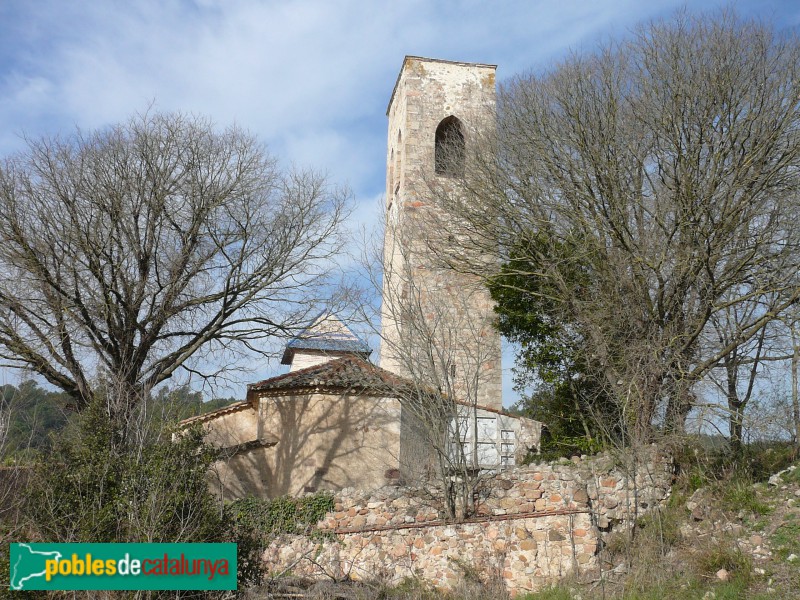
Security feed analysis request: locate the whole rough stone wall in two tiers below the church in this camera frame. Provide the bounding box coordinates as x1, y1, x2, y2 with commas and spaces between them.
265, 449, 672, 594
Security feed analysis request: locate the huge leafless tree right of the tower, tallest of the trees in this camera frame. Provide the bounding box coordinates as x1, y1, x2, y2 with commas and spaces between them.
434, 12, 800, 442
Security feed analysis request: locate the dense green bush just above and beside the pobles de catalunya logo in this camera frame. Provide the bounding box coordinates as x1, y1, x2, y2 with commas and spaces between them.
17, 403, 268, 586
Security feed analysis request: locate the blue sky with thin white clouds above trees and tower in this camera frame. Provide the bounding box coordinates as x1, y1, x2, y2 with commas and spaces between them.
0, 0, 800, 404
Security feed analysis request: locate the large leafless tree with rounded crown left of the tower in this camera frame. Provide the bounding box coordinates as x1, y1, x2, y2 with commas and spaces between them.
0, 113, 348, 409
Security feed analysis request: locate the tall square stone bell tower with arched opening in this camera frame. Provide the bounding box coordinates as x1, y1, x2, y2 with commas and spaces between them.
380, 56, 502, 408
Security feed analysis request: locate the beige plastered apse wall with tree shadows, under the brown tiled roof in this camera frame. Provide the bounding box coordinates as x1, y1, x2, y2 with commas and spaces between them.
215, 394, 400, 499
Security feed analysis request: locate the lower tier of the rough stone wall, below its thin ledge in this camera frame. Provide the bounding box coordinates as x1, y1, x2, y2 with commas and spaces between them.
267, 513, 597, 592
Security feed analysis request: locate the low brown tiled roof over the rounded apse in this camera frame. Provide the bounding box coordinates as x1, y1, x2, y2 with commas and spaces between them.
247, 355, 411, 394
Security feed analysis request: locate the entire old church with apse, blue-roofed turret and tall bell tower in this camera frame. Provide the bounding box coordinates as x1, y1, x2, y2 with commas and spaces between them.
182, 56, 541, 499
